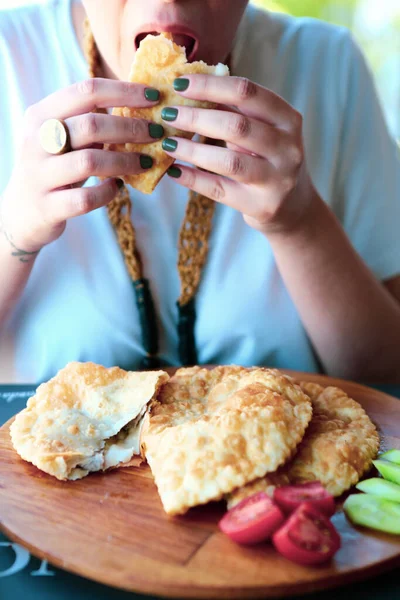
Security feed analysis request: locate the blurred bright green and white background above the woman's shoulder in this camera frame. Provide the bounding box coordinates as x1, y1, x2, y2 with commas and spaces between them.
251, 0, 400, 139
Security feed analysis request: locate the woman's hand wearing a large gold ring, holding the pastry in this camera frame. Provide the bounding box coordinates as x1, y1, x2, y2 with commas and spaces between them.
0, 79, 162, 253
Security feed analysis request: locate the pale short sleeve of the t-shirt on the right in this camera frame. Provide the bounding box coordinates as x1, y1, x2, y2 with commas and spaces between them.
335, 35, 400, 280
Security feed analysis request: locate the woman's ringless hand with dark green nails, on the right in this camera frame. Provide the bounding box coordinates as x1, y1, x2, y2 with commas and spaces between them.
162, 75, 316, 235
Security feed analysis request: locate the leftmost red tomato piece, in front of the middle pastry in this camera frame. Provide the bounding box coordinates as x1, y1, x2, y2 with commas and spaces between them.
218, 492, 285, 544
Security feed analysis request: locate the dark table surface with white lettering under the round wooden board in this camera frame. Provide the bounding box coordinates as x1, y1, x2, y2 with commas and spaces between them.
0, 385, 400, 600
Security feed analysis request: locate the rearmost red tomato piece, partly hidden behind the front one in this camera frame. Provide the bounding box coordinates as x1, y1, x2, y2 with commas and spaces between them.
274, 481, 336, 517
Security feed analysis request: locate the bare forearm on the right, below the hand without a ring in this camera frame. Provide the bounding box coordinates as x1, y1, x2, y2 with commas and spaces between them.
268, 190, 400, 381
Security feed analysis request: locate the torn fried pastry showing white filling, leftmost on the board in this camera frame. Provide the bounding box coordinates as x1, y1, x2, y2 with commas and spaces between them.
11, 362, 169, 479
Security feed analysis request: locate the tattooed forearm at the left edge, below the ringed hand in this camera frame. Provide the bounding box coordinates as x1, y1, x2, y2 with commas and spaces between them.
0, 222, 37, 331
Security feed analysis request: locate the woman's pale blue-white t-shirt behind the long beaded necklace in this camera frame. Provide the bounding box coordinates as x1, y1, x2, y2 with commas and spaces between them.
0, 0, 400, 382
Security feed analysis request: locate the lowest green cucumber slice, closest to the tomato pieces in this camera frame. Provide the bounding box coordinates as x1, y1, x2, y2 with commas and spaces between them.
343, 494, 400, 535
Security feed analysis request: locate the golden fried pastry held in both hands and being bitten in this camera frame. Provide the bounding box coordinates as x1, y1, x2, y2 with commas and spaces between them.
107, 33, 229, 194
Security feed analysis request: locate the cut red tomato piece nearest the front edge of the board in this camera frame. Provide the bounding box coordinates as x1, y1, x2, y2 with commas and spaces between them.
272, 502, 340, 565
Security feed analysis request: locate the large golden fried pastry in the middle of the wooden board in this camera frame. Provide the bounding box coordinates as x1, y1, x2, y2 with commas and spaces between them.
142, 367, 312, 515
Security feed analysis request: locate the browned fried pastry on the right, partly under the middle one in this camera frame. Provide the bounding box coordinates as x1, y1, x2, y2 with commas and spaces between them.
228, 382, 379, 508
